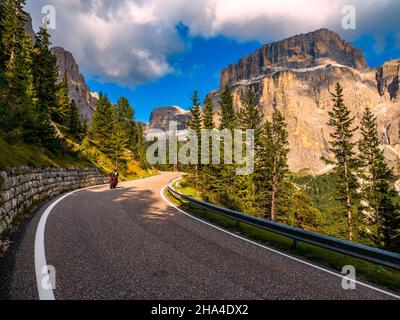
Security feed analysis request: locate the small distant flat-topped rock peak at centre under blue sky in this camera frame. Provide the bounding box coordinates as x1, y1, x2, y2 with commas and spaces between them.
146, 107, 190, 131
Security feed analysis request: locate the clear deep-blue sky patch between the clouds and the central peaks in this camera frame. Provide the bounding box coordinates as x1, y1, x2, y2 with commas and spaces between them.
88, 36, 260, 122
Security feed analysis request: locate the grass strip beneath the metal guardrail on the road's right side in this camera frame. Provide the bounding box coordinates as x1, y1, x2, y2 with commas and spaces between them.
166, 187, 400, 292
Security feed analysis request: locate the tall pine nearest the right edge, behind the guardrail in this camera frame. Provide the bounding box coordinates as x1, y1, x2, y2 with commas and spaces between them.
358, 107, 400, 249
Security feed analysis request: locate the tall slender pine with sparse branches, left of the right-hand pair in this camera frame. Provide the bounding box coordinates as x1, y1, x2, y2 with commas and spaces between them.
323, 83, 358, 241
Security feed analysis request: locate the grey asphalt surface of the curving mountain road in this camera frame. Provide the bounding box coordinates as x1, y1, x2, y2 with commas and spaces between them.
0, 173, 393, 300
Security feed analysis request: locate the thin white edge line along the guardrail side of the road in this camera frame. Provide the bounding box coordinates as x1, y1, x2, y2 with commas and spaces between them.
160, 185, 400, 299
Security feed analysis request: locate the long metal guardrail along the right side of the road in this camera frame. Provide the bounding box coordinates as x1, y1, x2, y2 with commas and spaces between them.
168, 178, 400, 270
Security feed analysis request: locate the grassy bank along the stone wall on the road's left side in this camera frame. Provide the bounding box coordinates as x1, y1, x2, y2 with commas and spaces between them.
0, 127, 157, 256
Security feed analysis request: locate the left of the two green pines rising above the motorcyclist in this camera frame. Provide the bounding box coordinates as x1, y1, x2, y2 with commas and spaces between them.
89, 93, 114, 155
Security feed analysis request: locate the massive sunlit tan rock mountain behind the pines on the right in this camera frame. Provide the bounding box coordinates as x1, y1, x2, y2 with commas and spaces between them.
210, 31, 400, 173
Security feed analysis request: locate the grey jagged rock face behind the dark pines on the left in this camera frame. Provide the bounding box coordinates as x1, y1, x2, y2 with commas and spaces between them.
51, 47, 98, 121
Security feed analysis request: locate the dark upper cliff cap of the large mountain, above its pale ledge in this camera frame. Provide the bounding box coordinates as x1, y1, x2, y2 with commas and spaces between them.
221, 29, 368, 87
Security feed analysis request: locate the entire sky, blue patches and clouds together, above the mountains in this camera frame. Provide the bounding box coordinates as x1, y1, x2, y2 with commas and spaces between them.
26, 0, 400, 122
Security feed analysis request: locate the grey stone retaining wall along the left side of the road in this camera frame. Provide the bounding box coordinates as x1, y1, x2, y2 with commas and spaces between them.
0, 167, 108, 252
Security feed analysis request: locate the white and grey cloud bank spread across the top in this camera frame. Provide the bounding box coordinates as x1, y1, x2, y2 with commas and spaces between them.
27, 0, 400, 86
